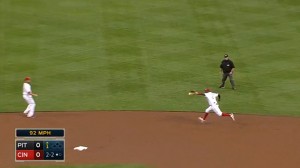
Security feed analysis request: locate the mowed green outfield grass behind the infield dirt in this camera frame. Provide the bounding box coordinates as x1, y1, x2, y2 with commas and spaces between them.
0, 0, 300, 116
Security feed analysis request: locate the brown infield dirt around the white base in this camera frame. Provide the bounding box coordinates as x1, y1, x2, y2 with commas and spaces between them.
0, 111, 300, 168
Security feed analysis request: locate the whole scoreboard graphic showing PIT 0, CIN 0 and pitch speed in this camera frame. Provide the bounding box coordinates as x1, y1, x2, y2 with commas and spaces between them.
15, 128, 65, 162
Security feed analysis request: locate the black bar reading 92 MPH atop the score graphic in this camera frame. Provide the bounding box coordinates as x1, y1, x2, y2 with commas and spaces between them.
16, 128, 65, 138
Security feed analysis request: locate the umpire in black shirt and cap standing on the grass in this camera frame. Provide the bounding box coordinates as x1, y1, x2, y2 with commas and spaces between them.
219, 54, 235, 90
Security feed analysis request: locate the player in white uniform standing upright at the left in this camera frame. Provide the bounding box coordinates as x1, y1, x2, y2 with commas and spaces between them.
23, 77, 38, 118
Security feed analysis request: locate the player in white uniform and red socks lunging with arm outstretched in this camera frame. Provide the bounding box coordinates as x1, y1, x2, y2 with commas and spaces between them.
189, 88, 235, 123
